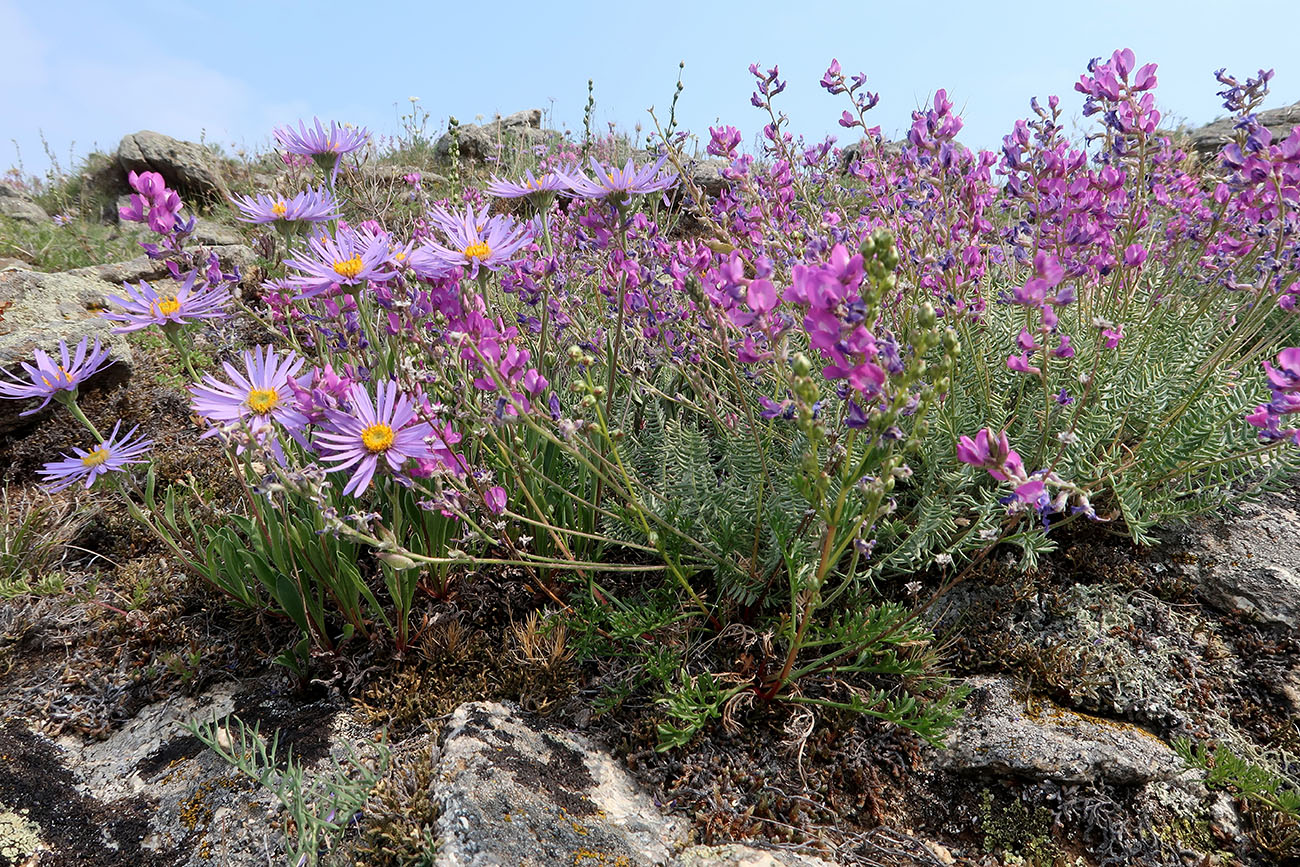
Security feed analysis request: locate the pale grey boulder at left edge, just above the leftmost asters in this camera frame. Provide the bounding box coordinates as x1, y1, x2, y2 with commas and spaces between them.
0, 270, 131, 434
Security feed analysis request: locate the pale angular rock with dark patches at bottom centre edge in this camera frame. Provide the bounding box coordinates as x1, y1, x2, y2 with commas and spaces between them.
436, 702, 685, 867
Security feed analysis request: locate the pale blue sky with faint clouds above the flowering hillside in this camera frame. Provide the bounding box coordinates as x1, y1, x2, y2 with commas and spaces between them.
0, 0, 1300, 173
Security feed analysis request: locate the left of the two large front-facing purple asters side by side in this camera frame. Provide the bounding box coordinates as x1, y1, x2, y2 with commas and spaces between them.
190, 346, 307, 441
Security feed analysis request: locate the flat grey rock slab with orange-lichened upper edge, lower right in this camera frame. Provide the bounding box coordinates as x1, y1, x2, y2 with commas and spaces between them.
935, 677, 1184, 785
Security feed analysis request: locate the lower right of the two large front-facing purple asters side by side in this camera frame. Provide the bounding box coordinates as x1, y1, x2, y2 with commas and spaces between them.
315, 380, 436, 494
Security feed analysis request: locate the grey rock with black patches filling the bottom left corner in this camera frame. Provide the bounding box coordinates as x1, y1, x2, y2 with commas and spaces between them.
0, 684, 369, 867
